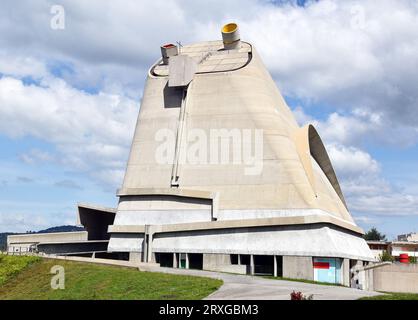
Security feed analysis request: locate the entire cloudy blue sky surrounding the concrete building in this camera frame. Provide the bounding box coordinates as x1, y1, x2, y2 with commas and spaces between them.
0, 0, 418, 238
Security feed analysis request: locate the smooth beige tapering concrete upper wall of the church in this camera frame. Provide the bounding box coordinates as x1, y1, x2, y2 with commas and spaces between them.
123, 42, 352, 222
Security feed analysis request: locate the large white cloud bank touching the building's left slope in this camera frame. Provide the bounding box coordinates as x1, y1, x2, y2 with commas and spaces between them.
0, 77, 139, 188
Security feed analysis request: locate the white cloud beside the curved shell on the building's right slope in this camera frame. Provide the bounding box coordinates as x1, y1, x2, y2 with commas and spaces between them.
294, 107, 418, 218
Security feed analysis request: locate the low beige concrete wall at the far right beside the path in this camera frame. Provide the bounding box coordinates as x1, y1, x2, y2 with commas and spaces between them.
374, 263, 418, 293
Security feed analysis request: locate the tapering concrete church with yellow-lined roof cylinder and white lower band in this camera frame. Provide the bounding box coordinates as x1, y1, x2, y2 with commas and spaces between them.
7, 23, 374, 285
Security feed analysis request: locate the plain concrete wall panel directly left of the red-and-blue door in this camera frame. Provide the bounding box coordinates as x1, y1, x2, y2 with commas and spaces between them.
283, 256, 314, 280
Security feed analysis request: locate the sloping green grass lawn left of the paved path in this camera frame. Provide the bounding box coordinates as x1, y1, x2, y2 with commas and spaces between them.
0, 257, 222, 300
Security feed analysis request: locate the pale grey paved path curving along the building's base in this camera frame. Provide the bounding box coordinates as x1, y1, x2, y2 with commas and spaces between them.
140, 267, 380, 300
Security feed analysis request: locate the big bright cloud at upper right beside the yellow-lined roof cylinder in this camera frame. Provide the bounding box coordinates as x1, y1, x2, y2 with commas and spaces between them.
242, 0, 418, 127
